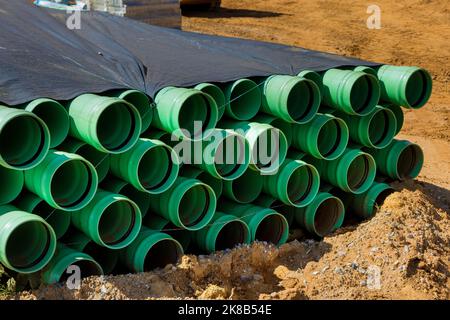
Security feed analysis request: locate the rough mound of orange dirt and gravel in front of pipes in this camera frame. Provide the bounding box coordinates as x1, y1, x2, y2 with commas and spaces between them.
11, 182, 450, 299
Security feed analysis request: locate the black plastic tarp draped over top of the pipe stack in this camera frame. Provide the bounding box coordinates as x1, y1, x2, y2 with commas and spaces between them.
0, 0, 376, 105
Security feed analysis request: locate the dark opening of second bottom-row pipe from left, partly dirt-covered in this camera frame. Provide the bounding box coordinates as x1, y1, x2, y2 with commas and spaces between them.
144, 239, 182, 272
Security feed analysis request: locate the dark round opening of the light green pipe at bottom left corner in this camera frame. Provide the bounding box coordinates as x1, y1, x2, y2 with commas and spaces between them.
5, 221, 51, 269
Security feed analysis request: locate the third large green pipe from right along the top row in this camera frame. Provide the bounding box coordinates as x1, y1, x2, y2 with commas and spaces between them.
261, 75, 321, 123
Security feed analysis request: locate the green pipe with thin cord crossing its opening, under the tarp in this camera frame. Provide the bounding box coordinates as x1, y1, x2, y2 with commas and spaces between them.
224, 79, 262, 120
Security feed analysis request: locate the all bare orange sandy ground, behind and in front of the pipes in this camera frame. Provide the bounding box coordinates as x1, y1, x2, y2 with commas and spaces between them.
4, 0, 450, 299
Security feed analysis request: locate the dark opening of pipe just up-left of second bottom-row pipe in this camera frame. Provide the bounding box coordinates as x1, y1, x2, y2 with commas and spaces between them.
98, 201, 137, 245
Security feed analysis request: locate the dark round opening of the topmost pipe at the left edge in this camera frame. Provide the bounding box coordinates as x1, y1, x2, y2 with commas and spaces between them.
0, 115, 48, 168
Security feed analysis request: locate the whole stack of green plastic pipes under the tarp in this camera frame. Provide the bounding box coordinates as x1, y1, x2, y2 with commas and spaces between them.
0, 65, 432, 284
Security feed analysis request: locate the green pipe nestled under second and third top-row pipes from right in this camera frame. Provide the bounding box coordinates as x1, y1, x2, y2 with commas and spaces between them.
292, 114, 349, 160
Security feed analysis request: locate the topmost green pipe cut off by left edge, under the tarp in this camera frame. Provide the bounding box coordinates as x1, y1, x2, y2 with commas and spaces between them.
0, 105, 50, 170
